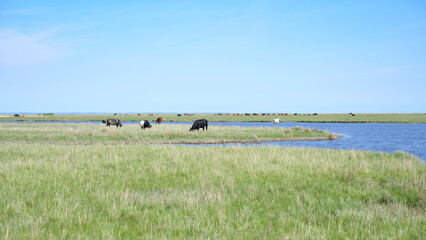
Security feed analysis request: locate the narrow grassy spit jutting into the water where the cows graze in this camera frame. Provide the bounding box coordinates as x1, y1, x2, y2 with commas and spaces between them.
0, 122, 338, 144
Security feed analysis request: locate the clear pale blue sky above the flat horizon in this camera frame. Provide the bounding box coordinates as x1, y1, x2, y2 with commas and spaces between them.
0, 0, 426, 113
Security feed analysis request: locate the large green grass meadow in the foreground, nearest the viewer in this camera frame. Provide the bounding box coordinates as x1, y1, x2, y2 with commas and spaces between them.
0, 142, 426, 239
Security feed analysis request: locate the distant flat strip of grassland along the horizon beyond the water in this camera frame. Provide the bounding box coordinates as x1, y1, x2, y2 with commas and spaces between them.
0, 113, 426, 123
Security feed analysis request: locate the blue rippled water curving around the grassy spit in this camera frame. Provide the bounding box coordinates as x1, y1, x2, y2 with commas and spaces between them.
1, 121, 426, 161
